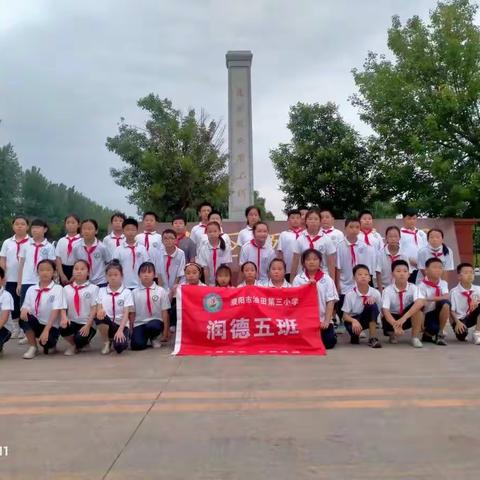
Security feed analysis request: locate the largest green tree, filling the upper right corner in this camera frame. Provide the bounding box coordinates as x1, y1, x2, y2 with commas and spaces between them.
352, 0, 480, 216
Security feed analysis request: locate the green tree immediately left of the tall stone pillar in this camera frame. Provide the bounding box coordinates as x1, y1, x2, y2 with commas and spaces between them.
107, 94, 228, 220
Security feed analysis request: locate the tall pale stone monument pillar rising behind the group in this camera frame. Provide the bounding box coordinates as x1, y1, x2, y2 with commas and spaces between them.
226, 50, 253, 220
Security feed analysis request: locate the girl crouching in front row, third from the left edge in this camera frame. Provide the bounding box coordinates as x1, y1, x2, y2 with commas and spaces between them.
60, 260, 98, 356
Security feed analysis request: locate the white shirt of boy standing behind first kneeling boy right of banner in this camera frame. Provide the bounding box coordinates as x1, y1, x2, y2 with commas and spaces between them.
337, 238, 377, 295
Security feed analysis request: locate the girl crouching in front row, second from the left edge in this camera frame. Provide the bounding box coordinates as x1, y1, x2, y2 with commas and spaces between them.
20, 260, 67, 360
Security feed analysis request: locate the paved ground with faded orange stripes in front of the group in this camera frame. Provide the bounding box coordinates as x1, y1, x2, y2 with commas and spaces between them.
0, 330, 480, 480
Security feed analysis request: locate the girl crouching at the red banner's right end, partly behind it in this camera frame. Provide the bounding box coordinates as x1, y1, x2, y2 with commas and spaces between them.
293, 248, 338, 350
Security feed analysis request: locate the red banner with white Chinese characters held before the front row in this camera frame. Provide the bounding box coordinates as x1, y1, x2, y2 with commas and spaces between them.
173, 285, 325, 355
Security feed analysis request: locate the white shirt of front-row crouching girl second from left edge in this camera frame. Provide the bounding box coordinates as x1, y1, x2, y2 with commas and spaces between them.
22, 282, 67, 328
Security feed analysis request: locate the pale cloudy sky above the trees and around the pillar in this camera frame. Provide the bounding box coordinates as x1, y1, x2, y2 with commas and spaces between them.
0, 0, 436, 219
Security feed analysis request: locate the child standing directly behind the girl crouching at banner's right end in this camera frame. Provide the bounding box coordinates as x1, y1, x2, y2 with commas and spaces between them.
292, 209, 337, 278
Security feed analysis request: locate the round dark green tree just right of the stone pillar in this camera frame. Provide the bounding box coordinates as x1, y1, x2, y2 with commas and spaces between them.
270, 103, 375, 216
